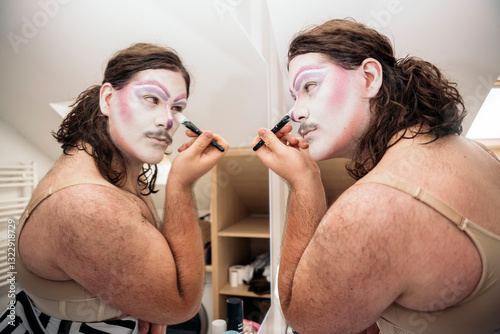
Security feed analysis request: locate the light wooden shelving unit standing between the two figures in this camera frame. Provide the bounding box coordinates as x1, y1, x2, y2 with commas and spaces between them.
210, 148, 271, 319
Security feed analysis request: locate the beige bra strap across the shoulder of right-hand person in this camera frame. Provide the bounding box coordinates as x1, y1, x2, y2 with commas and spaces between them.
356, 174, 469, 230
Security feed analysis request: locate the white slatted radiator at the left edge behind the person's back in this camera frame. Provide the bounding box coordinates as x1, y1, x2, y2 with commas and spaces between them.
0, 162, 38, 290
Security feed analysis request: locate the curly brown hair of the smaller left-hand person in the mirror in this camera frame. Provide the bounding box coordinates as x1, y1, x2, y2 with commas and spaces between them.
52, 43, 191, 195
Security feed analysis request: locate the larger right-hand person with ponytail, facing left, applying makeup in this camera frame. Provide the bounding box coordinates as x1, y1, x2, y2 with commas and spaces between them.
255, 20, 500, 334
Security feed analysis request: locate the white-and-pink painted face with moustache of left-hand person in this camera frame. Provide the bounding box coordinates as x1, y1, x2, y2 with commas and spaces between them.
101, 69, 187, 165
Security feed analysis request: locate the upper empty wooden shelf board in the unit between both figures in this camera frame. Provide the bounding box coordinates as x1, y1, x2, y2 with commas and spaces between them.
218, 216, 270, 239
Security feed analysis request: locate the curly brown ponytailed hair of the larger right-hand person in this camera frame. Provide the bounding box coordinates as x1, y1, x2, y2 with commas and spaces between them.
288, 19, 466, 179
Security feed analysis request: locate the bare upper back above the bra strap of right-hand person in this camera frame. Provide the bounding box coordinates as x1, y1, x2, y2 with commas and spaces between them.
374, 135, 500, 234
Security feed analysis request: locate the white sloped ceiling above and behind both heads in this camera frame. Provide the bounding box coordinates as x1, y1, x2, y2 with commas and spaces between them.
0, 0, 500, 159
